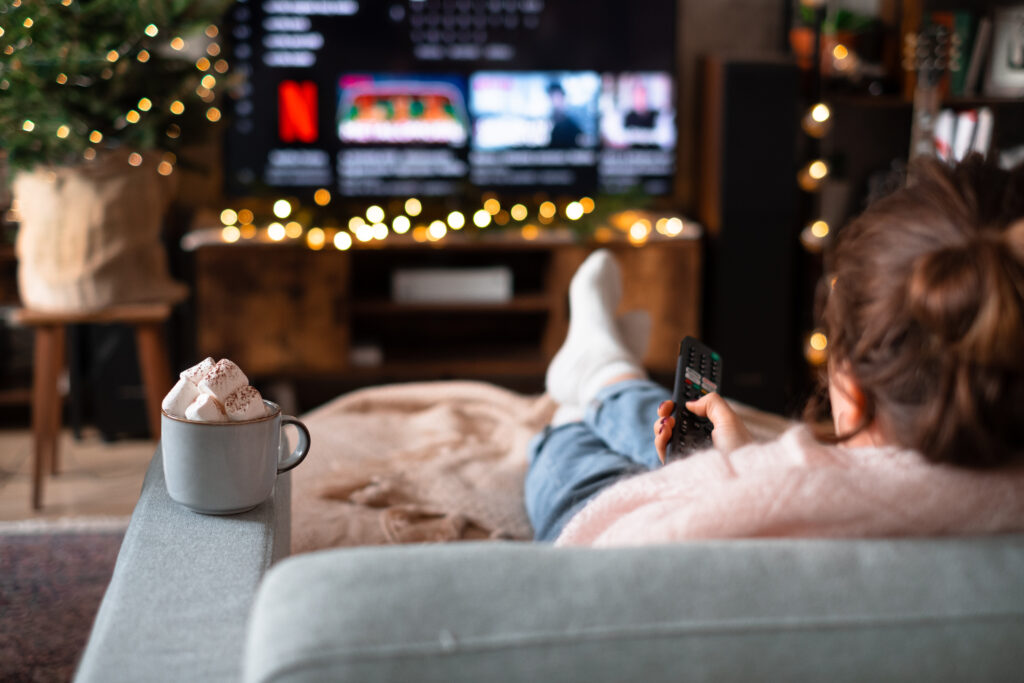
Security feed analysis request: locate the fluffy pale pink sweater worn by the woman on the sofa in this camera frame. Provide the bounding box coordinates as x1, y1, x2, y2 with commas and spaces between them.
556, 426, 1024, 546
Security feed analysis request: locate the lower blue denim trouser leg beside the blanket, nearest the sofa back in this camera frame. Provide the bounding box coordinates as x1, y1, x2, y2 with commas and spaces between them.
525, 422, 645, 541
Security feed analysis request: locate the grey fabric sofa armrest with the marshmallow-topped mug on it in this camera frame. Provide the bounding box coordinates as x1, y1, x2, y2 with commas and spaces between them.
75, 447, 291, 683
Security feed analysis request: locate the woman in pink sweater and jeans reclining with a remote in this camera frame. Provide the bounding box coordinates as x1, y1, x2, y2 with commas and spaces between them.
525, 157, 1024, 545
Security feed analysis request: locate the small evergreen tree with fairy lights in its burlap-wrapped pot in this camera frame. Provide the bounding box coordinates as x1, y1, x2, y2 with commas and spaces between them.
0, 0, 227, 310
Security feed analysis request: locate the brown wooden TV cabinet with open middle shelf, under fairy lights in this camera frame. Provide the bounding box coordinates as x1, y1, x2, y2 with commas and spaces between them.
196, 236, 701, 384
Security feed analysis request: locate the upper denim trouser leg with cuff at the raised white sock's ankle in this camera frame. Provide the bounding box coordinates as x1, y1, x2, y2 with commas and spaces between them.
584, 380, 672, 469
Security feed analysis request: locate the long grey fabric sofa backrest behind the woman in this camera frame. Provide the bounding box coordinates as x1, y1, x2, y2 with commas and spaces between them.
244, 536, 1024, 683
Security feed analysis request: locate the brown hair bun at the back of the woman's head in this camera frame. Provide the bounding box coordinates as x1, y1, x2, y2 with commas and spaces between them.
907, 236, 1022, 365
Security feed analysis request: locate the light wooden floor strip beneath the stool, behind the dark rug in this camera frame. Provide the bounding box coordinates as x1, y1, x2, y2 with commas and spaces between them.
0, 429, 157, 521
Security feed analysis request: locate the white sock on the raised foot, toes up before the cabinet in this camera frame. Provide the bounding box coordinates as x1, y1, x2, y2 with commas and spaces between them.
545, 249, 644, 405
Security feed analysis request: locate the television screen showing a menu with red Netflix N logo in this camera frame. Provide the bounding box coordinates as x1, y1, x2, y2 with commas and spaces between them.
225, 0, 676, 198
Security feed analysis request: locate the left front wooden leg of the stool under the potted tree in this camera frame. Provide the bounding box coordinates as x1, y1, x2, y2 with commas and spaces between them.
32, 325, 62, 510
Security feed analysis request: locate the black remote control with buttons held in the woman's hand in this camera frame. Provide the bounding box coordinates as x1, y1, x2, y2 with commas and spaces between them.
665, 337, 722, 462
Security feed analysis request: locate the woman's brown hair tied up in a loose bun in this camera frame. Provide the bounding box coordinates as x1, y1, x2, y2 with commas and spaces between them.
823, 155, 1024, 467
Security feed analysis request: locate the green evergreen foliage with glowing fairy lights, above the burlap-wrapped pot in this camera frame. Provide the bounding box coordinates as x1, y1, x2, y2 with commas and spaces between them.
0, 0, 228, 175
